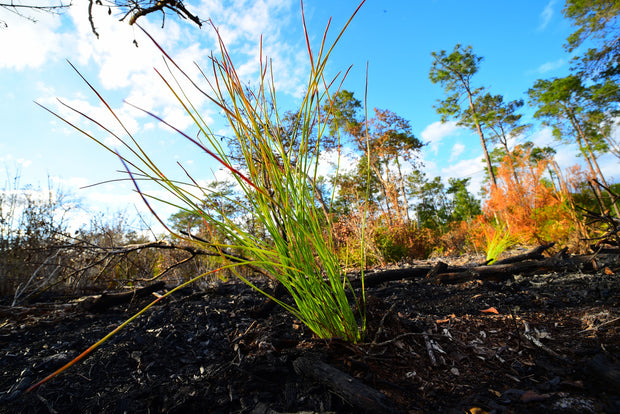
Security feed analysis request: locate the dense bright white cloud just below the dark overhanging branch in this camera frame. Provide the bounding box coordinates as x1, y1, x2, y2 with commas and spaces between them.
62, 5, 209, 119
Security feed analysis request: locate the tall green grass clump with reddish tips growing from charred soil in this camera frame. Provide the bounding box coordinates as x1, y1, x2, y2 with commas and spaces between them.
32, 2, 366, 388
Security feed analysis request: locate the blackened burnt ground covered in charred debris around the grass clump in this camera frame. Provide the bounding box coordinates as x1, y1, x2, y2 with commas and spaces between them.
0, 251, 620, 414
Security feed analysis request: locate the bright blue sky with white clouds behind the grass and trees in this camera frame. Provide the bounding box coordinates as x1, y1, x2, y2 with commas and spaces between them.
0, 0, 620, 231
